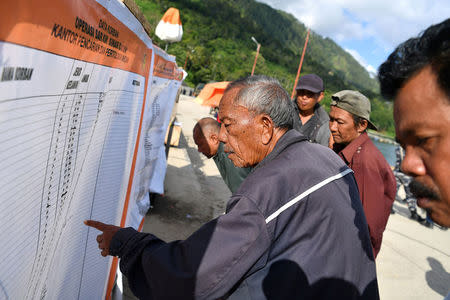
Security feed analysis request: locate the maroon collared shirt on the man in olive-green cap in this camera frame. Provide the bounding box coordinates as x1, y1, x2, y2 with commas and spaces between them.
338, 133, 396, 257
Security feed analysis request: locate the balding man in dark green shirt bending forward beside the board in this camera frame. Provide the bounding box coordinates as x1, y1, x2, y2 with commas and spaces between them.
193, 118, 252, 193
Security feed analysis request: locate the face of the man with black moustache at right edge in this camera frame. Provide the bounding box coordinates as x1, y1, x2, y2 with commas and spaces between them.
394, 67, 450, 227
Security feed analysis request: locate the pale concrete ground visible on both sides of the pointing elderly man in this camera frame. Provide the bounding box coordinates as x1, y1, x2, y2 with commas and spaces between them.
124, 96, 450, 300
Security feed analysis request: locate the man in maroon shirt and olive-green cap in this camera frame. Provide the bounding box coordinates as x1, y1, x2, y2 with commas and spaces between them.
330, 90, 396, 257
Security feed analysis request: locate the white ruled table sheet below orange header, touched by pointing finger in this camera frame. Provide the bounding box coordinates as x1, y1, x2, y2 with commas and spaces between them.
0, 45, 145, 299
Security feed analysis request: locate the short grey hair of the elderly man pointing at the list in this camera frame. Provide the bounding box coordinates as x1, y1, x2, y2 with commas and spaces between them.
225, 75, 294, 129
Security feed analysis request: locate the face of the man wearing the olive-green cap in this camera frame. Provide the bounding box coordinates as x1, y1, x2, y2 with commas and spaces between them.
330, 105, 361, 145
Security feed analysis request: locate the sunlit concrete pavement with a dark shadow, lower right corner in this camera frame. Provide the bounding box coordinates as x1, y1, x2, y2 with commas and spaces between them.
377, 203, 450, 300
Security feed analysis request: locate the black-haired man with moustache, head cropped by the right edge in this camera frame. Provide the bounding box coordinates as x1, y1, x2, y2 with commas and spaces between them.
378, 19, 450, 227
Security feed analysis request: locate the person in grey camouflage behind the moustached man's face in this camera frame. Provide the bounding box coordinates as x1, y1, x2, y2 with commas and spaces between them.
394, 145, 433, 227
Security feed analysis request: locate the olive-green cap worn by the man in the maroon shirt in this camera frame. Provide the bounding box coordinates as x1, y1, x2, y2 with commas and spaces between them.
331, 90, 378, 130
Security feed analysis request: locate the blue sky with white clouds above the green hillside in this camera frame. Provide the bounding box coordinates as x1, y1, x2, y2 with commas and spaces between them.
257, 0, 450, 72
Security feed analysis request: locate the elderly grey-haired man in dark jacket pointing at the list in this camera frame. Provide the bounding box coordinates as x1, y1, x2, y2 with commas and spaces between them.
86, 76, 378, 299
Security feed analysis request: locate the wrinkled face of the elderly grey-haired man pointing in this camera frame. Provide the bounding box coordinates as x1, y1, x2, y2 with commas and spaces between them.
219, 88, 265, 168
